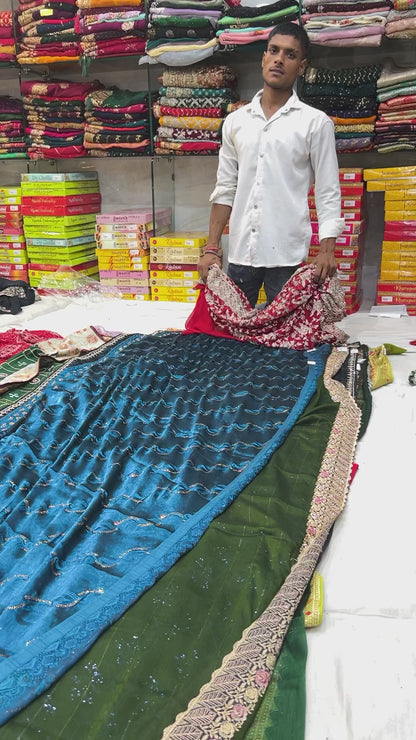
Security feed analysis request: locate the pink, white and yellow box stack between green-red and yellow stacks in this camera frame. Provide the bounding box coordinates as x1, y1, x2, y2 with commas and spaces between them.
95, 206, 172, 301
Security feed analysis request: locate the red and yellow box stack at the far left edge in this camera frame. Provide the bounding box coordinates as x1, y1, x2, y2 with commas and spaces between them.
0, 186, 29, 282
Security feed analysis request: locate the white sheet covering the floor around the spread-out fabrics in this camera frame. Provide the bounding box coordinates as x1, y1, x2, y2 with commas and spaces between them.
0, 297, 416, 740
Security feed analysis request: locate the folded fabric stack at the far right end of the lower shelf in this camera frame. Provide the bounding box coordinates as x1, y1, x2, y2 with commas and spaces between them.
374, 59, 416, 152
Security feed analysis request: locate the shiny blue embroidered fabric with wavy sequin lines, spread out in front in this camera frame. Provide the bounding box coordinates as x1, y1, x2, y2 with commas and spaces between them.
0, 332, 330, 723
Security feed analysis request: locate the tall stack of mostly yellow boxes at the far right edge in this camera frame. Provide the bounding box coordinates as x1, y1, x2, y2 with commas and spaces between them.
364, 167, 416, 314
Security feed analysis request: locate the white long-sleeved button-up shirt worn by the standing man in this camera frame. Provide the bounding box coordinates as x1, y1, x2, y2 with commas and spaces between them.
210, 90, 344, 267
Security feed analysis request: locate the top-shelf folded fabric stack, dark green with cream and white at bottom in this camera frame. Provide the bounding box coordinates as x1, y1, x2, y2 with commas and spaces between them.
146, 0, 224, 66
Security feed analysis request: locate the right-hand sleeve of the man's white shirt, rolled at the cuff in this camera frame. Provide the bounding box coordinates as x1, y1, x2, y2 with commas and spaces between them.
311, 117, 345, 241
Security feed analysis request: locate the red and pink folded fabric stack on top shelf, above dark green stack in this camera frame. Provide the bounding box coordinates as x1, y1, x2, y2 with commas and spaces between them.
76, 0, 146, 67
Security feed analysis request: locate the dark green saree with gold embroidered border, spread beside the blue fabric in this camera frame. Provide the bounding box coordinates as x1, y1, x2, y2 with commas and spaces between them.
2, 342, 368, 740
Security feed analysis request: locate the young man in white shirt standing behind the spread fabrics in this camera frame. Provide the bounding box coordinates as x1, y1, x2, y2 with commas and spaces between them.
198, 22, 344, 306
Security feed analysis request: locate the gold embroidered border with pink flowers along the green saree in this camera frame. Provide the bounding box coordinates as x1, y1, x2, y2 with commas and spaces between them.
162, 348, 361, 740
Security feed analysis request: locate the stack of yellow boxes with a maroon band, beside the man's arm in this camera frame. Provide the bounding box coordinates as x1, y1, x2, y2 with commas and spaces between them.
150, 231, 208, 303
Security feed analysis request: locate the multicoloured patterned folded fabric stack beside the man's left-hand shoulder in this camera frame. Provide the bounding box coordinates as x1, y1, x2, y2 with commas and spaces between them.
153, 65, 238, 154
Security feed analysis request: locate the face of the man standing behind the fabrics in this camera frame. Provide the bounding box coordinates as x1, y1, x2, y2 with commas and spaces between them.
261, 34, 306, 90
